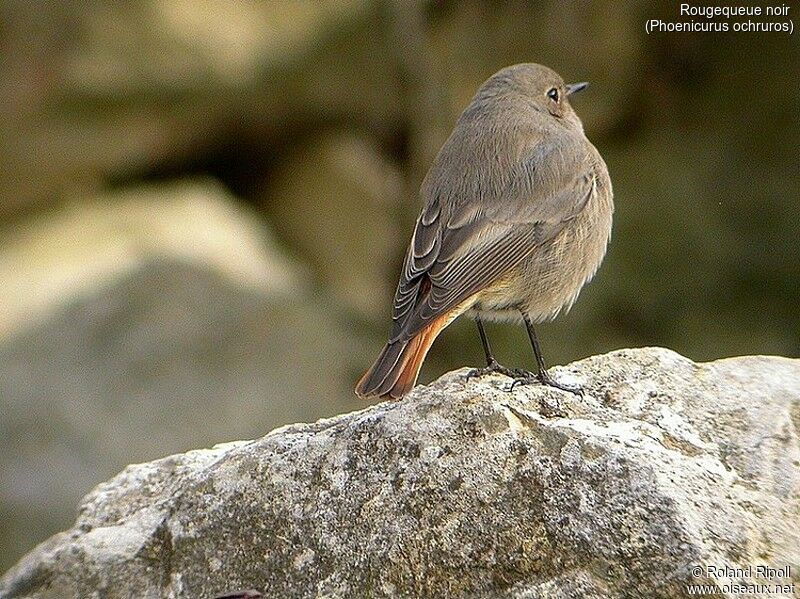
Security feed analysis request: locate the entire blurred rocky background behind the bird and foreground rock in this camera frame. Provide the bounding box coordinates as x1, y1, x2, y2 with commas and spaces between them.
0, 0, 800, 570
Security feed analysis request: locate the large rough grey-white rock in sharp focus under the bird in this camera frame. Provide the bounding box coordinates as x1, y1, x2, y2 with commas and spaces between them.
0, 349, 800, 598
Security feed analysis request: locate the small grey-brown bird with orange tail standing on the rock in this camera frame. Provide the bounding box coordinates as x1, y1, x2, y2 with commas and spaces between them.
355, 63, 614, 400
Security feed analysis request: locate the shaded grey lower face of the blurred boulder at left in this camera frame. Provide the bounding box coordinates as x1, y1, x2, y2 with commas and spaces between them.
0, 258, 368, 576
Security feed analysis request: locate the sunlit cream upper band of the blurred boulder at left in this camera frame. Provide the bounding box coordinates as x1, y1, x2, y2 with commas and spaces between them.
0, 179, 301, 342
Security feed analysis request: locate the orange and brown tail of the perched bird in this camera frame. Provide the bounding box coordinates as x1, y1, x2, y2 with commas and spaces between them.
356, 314, 452, 399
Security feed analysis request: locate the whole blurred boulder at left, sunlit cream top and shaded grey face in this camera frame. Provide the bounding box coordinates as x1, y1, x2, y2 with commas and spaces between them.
0, 181, 368, 571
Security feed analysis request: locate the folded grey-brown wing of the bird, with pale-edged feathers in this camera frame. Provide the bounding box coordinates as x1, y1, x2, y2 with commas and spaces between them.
390, 139, 599, 341
